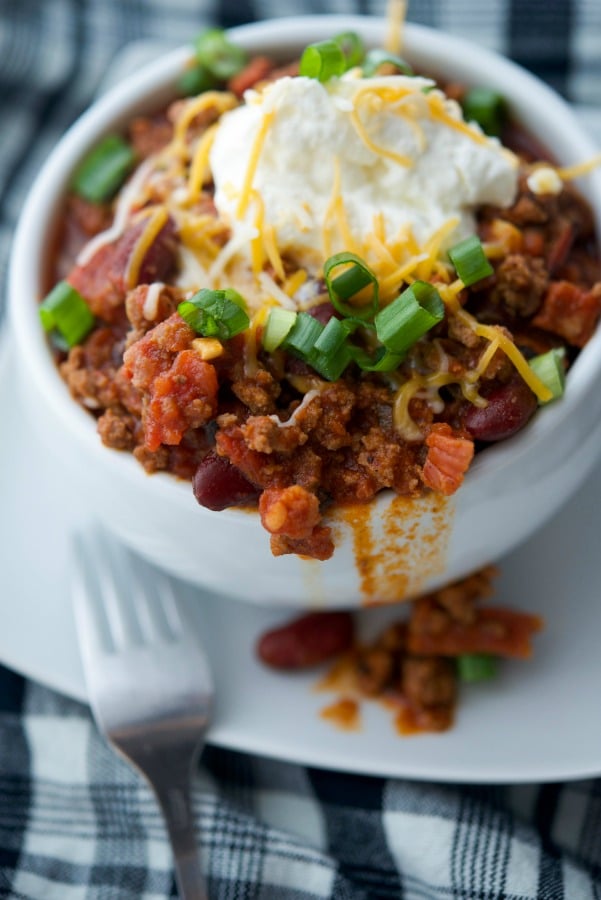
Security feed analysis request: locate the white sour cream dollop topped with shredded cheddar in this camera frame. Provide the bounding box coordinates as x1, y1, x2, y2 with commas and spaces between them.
210, 72, 517, 266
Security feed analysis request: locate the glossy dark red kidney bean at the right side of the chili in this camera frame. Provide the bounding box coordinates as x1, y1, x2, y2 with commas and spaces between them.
463, 378, 537, 442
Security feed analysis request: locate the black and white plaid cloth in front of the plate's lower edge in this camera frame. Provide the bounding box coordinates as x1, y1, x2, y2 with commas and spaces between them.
0, 667, 601, 900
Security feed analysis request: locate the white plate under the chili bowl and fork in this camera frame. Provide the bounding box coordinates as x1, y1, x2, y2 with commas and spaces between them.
0, 332, 601, 783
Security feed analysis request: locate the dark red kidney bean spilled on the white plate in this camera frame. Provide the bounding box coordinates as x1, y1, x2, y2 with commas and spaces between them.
257, 612, 353, 669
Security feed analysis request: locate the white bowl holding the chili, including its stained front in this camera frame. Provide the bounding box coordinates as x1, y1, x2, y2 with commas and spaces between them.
10, 16, 601, 607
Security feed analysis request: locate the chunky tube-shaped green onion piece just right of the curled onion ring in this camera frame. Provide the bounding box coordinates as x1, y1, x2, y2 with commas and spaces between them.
374, 281, 444, 354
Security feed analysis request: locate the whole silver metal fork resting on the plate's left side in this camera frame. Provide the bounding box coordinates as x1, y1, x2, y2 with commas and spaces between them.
72, 529, 213, 900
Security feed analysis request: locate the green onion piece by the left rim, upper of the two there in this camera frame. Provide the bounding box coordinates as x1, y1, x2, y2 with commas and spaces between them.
71, 134, 136, 203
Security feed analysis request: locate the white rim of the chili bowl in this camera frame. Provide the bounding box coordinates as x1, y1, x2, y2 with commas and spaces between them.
8, 15, 601, 518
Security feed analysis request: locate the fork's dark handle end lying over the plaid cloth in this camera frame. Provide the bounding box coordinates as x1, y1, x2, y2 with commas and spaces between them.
153, 772, 209, 900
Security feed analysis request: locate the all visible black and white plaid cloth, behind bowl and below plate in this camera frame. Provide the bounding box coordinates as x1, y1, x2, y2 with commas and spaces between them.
0, 0, 601, 900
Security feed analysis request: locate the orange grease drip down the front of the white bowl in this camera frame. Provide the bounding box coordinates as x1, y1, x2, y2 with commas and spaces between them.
336, 493, 454, 605
